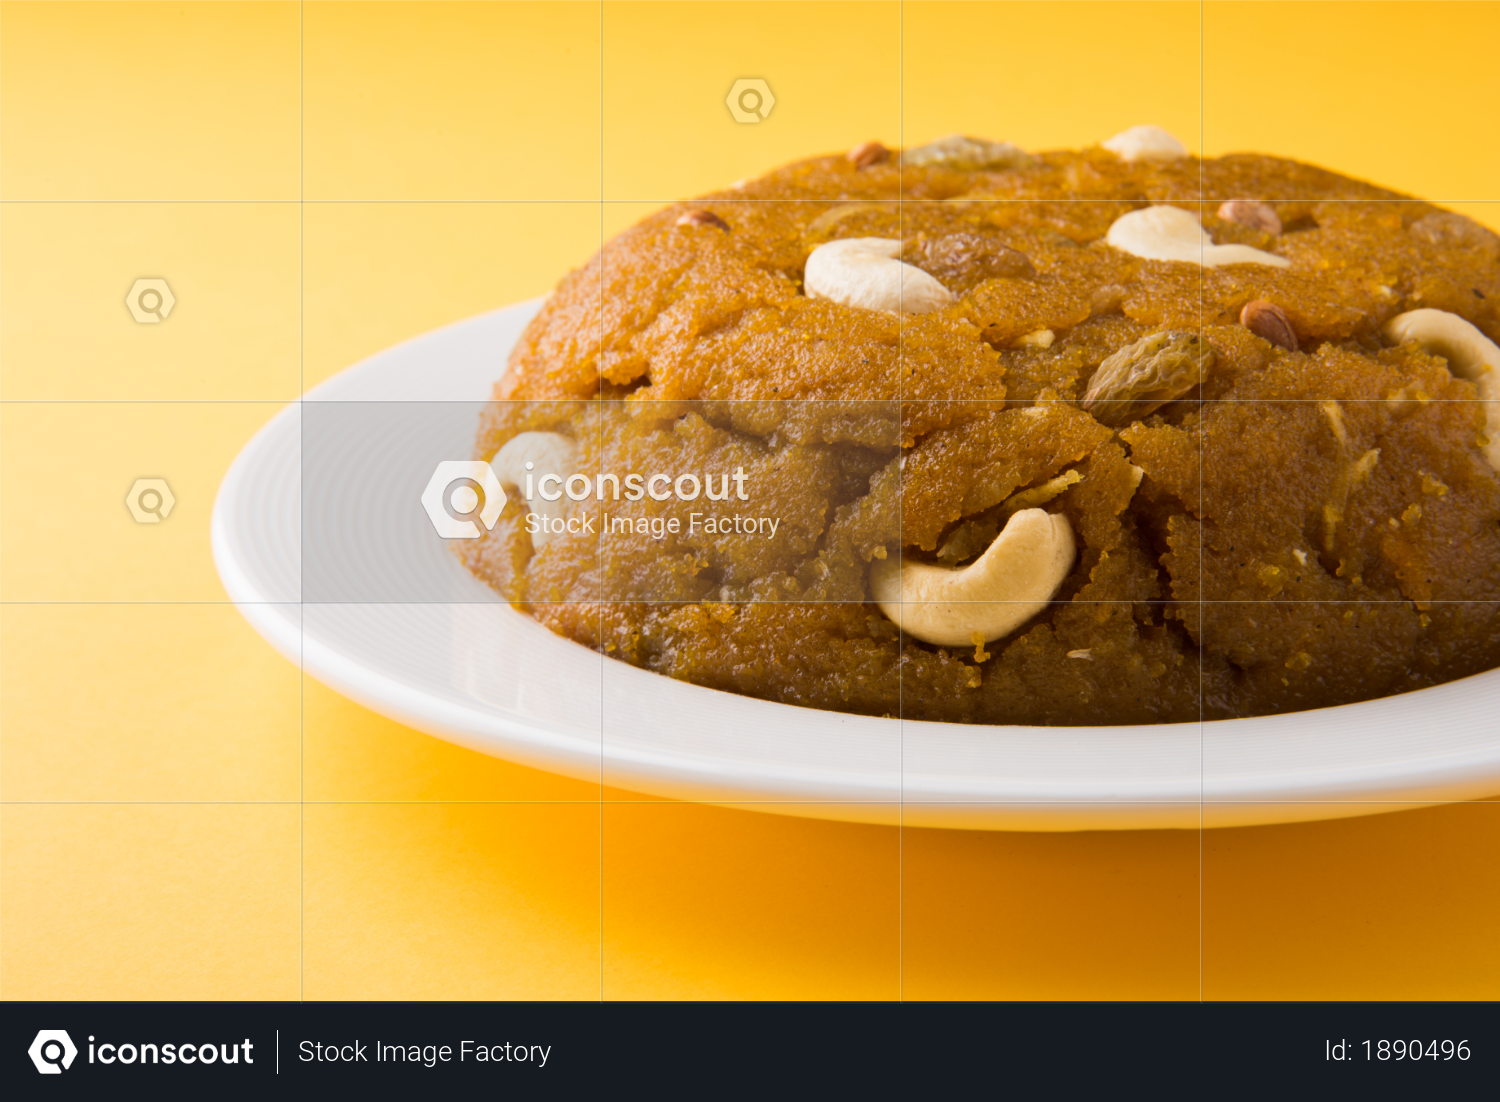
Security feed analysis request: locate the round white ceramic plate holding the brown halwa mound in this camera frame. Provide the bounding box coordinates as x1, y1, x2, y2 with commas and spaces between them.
213, 301, 1500, 831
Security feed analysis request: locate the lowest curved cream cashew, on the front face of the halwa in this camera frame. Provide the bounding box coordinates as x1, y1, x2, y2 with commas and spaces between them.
870, 508, 1076, 646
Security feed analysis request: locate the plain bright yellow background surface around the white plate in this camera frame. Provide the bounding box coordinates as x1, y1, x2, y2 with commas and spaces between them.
0, 0, 1500, 999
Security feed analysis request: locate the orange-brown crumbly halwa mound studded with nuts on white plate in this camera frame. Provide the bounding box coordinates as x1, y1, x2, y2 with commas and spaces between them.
459, 148, 1500, 724
